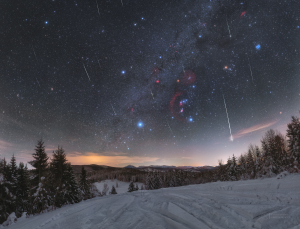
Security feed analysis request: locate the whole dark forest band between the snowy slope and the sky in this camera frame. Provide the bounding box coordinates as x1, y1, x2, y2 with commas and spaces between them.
0, 116, 300, 224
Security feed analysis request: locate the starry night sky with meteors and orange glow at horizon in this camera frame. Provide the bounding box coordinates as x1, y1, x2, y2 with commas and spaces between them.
0, 0, 300, 166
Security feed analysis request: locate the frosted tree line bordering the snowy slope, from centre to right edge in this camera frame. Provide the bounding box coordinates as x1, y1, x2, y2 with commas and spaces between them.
145, 116, 300, 190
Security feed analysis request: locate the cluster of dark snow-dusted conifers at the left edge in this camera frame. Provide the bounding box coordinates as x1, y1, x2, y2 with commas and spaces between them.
0, 140, 97, 223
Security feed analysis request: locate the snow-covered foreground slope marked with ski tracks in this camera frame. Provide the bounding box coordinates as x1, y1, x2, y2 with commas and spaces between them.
4, 174, 300, 229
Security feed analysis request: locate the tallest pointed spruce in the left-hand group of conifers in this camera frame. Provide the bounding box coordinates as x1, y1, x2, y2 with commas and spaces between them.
29, 139, 49, 186
